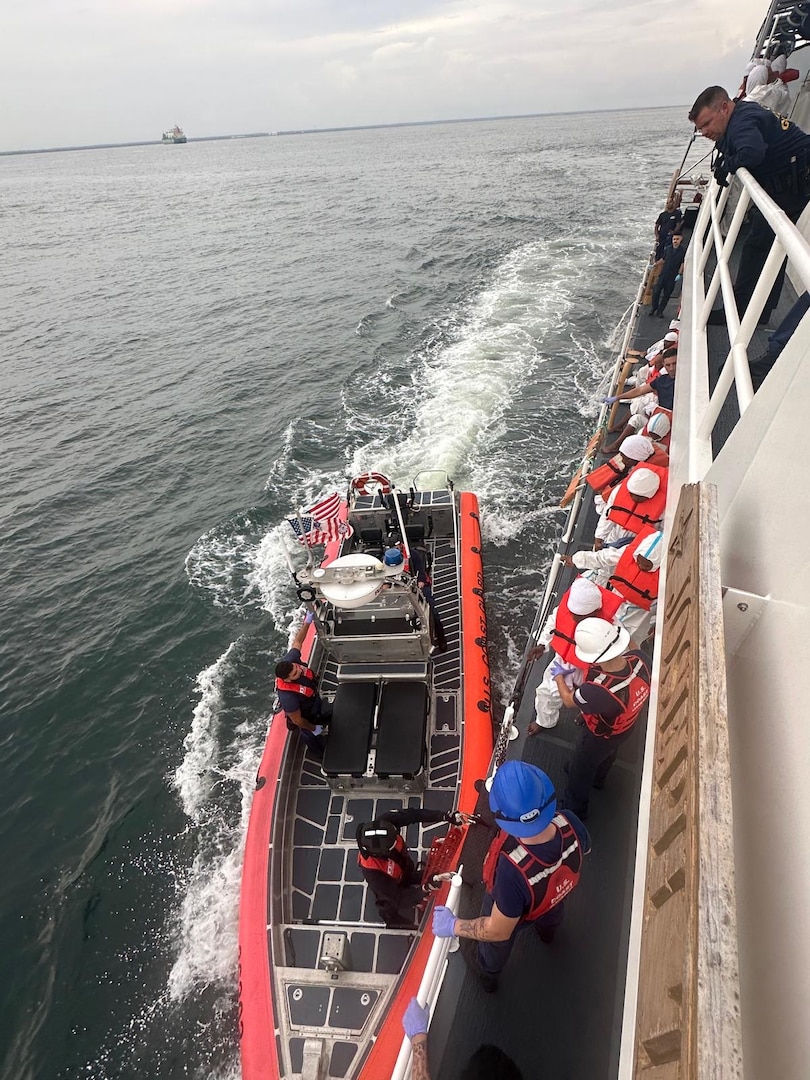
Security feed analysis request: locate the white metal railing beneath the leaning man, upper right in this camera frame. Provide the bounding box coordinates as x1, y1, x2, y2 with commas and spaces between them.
684, 168, 810, 482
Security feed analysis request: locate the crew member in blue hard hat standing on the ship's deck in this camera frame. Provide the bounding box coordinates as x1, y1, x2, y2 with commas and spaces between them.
433, 761, 591, 993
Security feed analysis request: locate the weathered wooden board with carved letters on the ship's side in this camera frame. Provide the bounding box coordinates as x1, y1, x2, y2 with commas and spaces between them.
634, 484, 742, 1080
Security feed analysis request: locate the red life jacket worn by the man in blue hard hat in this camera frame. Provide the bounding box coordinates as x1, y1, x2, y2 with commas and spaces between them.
484, 813, 582, 922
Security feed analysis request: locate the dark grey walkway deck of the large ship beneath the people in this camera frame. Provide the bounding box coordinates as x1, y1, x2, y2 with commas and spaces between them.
429, 219, 796, 1080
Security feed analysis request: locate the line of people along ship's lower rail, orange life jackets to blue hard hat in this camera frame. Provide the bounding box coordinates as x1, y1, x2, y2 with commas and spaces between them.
395, 323, 678, 1076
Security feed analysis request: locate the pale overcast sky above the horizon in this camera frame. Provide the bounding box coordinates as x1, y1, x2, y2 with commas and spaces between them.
0, 0, 767, 150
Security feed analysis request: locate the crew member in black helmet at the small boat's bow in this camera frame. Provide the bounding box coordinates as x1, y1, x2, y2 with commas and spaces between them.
356, 810, 473, 930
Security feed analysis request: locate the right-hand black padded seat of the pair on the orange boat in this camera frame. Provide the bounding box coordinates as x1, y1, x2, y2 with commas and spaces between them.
374, 683, 428, 778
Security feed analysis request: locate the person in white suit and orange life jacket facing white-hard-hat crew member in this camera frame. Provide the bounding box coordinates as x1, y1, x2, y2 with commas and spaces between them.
526, 578, 621, 735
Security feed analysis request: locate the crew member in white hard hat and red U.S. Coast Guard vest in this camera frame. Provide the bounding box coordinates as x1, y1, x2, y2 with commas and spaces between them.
558, 619, 650, 821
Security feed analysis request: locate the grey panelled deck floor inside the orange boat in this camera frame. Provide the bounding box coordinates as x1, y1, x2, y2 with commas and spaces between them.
268, 527, 462, 1078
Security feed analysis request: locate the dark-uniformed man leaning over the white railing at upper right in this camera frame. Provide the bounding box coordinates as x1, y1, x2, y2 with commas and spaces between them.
689, 86, 810, 322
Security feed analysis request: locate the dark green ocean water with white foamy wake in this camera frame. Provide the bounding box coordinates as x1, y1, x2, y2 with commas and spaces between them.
0, 109, 689, 1080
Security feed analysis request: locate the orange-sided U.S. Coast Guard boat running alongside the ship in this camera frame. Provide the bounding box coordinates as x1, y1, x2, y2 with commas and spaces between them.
239, 472, 492, 1080
